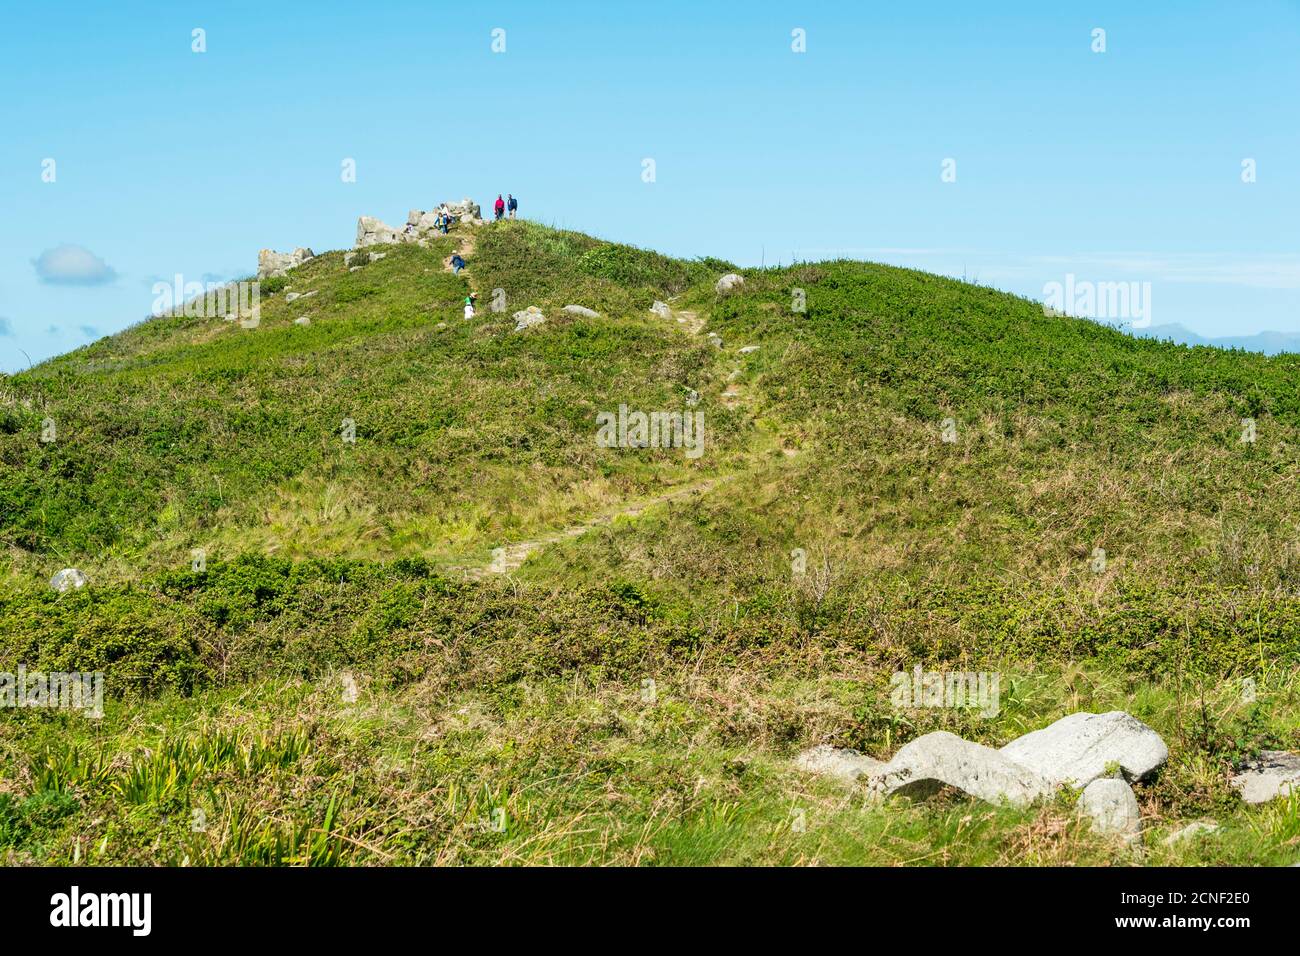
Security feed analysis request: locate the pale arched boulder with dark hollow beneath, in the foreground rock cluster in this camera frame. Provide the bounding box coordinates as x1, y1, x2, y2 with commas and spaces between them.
867, 731, 1052, 806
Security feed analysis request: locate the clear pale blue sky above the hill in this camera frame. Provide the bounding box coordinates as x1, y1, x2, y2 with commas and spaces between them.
0, 0, 1300, 371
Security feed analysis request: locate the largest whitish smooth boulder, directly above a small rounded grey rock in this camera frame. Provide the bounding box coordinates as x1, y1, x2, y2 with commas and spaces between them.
1001, 710, 1169, 788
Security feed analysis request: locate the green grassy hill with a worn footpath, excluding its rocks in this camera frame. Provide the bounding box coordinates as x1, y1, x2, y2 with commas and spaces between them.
0, 221, 1300, 864
